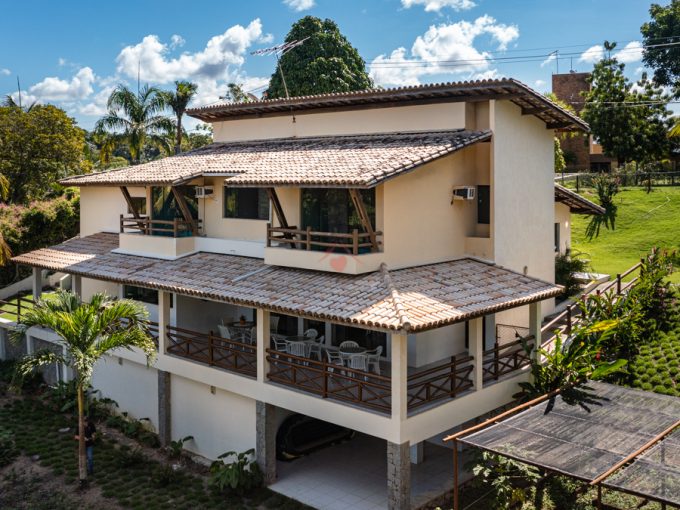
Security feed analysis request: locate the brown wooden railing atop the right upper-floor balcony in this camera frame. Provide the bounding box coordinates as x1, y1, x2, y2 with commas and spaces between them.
267, 223, 382, 255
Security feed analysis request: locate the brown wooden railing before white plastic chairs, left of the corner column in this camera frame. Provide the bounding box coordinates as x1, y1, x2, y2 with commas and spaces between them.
267, 349, 392, 413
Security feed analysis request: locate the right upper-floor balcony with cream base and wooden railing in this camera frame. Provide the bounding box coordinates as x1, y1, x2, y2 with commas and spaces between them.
265, 224, 383, 274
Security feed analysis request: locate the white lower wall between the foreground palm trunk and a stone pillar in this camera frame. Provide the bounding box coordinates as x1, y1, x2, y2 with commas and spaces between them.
92, 356, 158, 430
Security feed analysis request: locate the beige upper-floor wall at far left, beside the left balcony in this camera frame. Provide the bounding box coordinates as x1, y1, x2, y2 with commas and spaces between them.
80, 186, 146, 236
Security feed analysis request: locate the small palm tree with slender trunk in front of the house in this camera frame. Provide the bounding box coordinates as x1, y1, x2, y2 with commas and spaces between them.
13, 291, 156, 482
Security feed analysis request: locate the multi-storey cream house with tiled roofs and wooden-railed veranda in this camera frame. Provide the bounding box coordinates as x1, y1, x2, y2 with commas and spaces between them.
5, 79, 587, 509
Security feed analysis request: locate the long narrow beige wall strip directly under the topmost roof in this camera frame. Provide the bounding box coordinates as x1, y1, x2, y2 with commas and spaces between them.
213, 103, 465, 142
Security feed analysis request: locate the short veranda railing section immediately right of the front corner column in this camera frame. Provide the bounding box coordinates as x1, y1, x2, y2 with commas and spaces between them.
407, 356, 474, 410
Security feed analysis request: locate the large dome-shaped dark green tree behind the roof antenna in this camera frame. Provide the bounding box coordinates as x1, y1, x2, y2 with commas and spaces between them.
265, 16, 373, 99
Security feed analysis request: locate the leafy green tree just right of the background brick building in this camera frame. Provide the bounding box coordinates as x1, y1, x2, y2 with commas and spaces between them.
582, 41, 670, 166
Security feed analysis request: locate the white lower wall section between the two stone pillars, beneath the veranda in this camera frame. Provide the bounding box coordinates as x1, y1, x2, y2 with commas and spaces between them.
171, 375, 255, 459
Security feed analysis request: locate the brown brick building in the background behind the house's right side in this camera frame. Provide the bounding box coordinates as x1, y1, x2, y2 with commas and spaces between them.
552, 71, 616, 172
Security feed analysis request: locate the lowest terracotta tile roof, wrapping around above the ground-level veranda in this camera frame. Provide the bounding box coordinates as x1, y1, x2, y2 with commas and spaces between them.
12, 233, 562, 332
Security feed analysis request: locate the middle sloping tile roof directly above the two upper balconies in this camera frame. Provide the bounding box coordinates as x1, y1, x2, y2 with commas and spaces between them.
60, 129, 491, 188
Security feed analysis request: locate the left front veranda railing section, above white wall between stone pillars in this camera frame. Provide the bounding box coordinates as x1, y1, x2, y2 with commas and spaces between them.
167, 326, 257, 377
